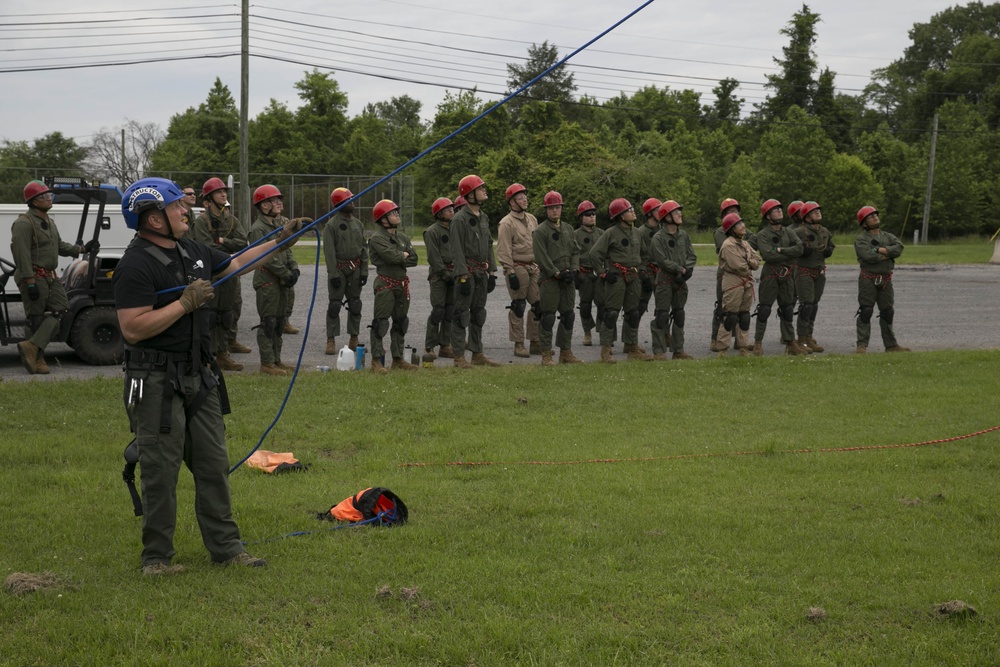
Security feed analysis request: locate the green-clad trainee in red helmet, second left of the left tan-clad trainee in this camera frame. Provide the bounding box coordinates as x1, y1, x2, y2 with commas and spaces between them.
421, 197, 455, 365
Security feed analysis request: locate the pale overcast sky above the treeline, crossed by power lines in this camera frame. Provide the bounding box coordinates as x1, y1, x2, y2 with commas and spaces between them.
0, 0, 948, 144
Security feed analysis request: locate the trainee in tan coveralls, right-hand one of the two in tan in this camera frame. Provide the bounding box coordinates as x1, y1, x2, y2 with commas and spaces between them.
718, 213, 760, 357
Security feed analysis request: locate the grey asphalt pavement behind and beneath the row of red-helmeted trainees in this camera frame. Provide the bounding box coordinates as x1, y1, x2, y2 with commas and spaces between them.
0, 264, 1000, 381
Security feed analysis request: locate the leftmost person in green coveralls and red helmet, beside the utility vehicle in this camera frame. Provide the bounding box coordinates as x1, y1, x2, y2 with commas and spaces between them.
10, 181, 91, 375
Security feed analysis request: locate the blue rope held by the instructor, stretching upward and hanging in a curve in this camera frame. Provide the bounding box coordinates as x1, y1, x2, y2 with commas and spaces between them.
226, 0, 653, 474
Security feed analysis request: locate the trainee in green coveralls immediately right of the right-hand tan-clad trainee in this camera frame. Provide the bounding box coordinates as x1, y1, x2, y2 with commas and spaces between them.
753, 199, 807, 356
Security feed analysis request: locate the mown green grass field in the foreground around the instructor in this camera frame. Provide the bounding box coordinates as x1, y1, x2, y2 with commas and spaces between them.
0, 351, 1000, 665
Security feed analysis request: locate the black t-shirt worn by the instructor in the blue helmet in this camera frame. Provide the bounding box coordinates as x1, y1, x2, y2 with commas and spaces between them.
111, 237, 229, 352
